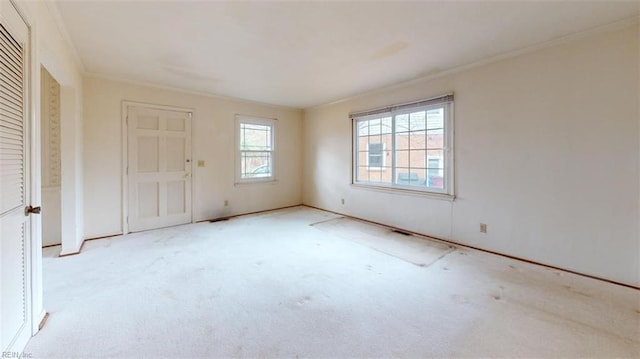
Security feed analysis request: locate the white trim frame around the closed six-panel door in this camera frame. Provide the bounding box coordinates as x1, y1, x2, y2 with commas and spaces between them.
121, 100, 196, 234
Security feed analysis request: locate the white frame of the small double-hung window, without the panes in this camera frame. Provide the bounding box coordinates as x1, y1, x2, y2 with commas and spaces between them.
235, 115, 277, 184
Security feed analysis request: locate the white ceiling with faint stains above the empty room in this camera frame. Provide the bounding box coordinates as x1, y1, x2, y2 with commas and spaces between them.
57, 0, 640, 108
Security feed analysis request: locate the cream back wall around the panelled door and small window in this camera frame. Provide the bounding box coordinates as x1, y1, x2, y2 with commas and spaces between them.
84, 77, 302, 238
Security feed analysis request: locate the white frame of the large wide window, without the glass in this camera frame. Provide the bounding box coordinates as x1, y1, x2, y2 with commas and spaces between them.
350, 94, 455, 200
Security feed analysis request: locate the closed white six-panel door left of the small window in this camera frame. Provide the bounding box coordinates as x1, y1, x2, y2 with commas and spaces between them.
127, 105, 191, 232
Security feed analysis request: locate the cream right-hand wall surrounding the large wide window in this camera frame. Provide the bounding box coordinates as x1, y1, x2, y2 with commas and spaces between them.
303, 25, 640, 286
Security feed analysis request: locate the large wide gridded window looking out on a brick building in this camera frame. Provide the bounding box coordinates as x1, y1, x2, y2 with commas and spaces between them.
351, 95, 453, 196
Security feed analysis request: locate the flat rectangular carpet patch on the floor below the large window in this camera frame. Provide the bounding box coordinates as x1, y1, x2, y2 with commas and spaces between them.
312, 217, 455, 266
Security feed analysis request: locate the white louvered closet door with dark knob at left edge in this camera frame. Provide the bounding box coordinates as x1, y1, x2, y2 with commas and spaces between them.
0, 0, 31, 352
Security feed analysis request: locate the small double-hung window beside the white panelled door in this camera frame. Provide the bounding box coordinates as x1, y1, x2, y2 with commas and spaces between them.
236, 116, 275, 182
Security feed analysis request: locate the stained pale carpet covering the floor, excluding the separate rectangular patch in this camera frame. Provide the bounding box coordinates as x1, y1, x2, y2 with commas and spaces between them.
26, 207, 640, 358
